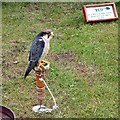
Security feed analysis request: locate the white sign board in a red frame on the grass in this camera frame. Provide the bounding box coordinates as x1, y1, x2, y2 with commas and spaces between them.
83, 3, 118, 22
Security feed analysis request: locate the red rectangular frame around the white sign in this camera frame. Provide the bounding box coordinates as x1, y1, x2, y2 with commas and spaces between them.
82, 3, 118, 23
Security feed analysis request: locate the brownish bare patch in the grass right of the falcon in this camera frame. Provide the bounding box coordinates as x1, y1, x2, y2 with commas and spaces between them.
49, 51, 97, 76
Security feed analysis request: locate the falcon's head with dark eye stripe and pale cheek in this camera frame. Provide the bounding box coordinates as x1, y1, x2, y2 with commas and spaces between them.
40, 29, 54, 40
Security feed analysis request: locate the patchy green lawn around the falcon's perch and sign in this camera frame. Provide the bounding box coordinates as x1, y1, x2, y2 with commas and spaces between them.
2, 3, 119, 118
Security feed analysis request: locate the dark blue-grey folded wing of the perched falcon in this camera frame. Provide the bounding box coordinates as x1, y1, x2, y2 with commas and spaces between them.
29, 39, 45, 62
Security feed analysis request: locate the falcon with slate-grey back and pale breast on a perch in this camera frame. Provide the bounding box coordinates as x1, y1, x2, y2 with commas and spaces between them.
24, 29, 54, 79
